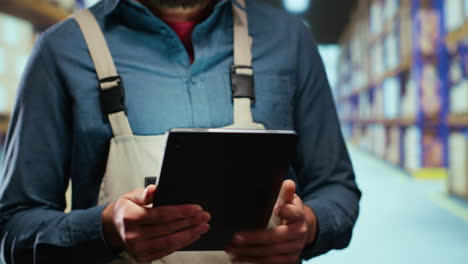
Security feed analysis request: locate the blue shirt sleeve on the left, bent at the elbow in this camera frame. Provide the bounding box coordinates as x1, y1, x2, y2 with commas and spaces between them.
0, 33, 114, 263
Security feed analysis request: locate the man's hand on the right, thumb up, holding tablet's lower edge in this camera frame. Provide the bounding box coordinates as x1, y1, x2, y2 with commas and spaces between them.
226, 180, 317, 264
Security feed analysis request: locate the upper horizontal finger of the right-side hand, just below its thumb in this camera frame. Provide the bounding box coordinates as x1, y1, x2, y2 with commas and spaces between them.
233, 223, 307, 245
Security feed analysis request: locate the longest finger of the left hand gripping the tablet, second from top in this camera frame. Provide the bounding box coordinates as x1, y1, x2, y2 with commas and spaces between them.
126, 212, 211, 240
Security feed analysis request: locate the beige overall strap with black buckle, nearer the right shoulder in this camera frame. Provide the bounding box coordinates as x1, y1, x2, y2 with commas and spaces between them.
231, 0, 255, 124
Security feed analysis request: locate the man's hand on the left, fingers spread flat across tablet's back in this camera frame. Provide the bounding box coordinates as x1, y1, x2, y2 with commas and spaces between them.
102, 185, 210, 262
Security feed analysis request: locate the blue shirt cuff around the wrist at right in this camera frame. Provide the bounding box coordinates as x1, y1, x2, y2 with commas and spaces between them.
301, 200, 334, 260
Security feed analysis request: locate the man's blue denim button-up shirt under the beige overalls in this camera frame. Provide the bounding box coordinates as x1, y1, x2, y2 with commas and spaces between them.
0, 0, 360, 263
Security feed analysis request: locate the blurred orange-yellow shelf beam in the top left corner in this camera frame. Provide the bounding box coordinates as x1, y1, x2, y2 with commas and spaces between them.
0, 0, 70, 30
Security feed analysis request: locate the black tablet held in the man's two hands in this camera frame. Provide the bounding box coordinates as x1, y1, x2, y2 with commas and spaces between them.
154, 129, 297, 251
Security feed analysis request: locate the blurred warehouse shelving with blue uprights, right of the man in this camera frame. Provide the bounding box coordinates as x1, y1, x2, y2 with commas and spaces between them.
336, 0, 468, 199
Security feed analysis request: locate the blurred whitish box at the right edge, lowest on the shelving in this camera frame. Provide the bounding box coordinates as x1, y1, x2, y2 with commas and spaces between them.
449, 132, 468, 198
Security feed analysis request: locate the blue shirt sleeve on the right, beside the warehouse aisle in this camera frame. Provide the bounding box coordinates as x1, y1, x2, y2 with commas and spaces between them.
293, 23, 361, 259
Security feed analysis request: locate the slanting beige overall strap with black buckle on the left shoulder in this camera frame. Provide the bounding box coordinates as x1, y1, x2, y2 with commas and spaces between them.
73, 9, 133, 137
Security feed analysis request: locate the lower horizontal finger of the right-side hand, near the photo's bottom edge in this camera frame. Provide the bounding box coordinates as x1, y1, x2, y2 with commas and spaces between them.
226, 239, 304, 258
